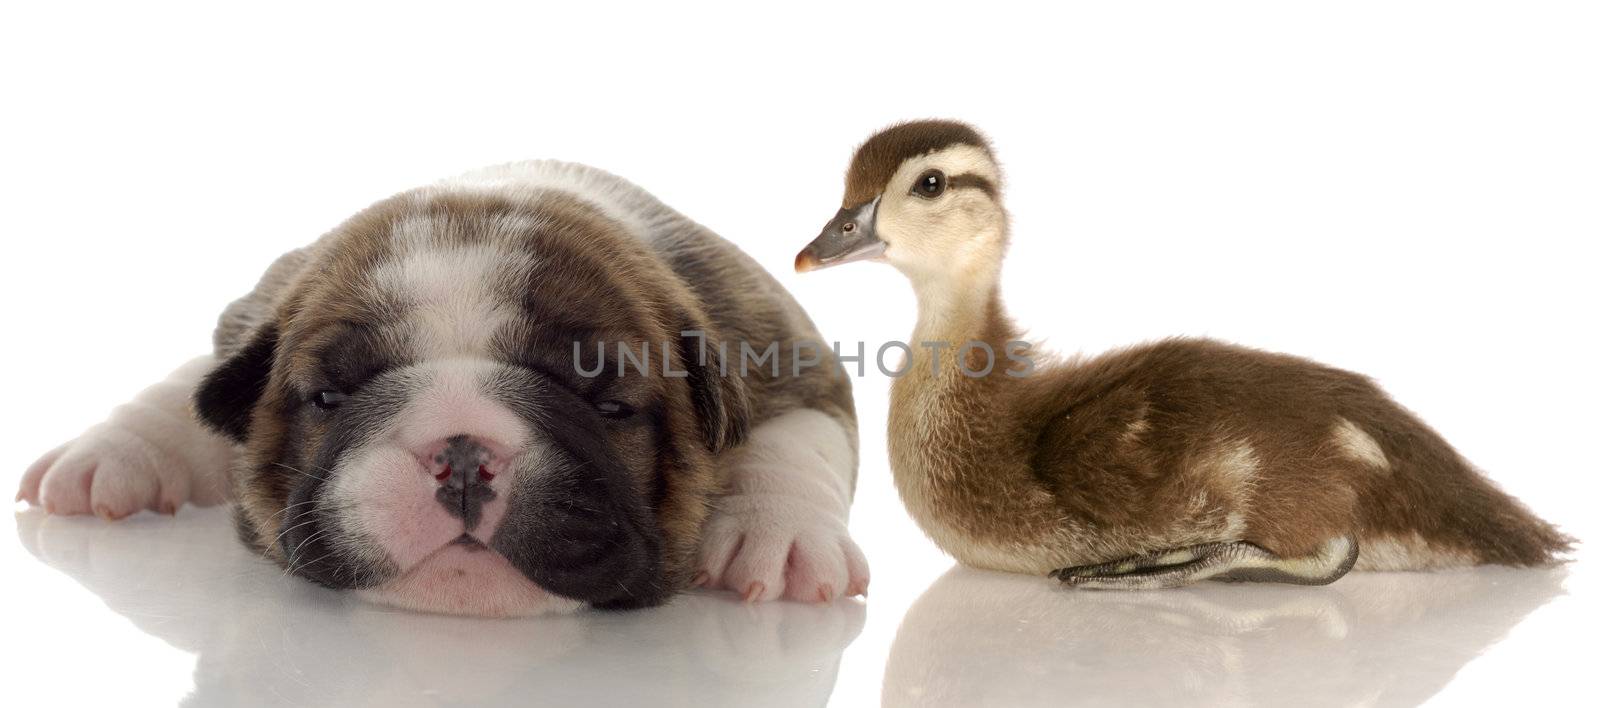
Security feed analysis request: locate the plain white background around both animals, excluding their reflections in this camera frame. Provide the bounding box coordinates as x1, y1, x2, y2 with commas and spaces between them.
0, 2, 1600, 702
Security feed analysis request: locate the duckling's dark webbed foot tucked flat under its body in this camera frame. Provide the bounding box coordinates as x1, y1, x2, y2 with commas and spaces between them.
1050, 537, 1358, 589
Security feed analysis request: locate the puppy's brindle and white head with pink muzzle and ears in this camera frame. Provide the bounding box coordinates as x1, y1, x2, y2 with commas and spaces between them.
195, 191, 746, 615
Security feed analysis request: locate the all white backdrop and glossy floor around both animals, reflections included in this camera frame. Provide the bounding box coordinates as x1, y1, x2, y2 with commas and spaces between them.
0, 0, 1600, 708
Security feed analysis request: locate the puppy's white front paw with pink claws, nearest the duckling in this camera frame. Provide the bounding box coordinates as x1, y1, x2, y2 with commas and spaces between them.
696, 495, 869, 602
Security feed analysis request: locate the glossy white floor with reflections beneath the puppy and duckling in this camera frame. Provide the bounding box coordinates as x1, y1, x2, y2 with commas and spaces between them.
0, 509, 1595, 706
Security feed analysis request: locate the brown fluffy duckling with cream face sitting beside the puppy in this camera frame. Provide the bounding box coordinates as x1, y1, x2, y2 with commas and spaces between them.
795, 120, 1571, 589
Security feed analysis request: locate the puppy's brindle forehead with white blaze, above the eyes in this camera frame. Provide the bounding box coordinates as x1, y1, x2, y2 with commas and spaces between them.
285, 192, 648, 373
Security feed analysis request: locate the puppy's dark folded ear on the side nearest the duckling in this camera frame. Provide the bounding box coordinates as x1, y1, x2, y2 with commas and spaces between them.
677, 322, 750, 452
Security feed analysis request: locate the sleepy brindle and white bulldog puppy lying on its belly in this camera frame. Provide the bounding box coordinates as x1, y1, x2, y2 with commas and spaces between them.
19, 162, 867, 615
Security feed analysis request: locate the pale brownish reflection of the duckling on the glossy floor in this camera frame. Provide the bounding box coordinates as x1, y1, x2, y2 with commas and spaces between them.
883, 567, 1566, 706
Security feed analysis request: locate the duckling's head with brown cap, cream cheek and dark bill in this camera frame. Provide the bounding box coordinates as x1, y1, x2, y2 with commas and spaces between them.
795, 120, 1006, 282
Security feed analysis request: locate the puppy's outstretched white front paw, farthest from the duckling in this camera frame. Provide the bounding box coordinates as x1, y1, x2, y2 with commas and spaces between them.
16, 420, 230, 519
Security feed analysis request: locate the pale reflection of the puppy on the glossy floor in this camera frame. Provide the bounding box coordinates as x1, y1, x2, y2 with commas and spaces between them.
16, 509, 866, 706
